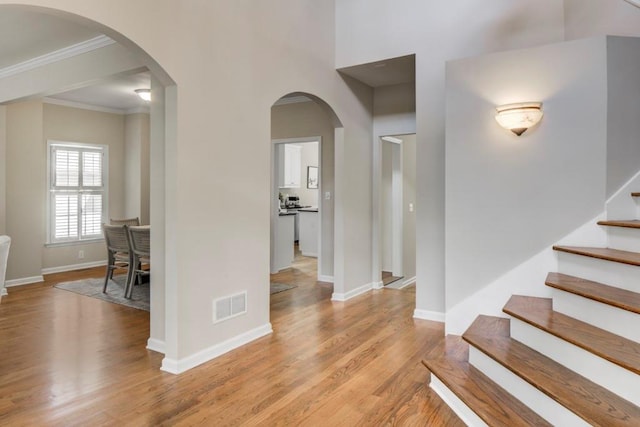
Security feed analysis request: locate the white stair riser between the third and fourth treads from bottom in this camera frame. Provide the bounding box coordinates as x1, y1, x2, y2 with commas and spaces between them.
553, 289, 640, 343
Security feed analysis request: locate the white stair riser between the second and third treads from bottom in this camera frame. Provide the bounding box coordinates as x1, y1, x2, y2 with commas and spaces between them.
511, 318, 640, 405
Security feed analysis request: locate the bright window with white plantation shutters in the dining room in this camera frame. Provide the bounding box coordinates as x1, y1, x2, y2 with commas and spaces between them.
48, 141, 108, 243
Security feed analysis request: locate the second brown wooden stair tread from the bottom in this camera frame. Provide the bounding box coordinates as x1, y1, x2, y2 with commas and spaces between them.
463, 316, 640, 426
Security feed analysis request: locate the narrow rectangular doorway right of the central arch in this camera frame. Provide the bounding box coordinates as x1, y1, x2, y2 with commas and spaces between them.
378, 134, 416, 289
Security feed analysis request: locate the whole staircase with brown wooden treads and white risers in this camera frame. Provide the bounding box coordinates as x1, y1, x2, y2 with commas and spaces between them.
423, 193, 640, 426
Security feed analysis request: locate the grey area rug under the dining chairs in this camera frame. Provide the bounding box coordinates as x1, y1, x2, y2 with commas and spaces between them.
55, 274, 150, 311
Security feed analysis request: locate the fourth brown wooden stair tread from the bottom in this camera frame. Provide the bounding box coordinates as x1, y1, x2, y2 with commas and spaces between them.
545, 273, 640, 314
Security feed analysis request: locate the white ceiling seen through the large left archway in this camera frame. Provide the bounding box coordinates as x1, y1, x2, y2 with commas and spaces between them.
0, 7, 150, 112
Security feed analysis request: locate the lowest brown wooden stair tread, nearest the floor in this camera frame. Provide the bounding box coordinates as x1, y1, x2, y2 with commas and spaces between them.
422, 336, 551, 426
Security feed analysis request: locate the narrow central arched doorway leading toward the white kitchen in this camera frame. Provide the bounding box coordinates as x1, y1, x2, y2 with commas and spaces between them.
271, 92, 342, 314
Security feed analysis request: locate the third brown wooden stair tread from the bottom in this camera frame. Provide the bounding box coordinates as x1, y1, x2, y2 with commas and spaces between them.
503, 295, 640, 374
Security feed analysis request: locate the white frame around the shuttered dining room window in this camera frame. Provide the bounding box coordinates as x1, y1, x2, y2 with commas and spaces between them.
45, 140, 109, 247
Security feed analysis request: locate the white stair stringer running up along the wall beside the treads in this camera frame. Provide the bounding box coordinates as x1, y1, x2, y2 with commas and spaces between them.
445, 211, 607, 335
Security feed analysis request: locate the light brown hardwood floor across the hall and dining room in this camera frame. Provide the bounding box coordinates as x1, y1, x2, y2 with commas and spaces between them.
0, 252, 463, 426
